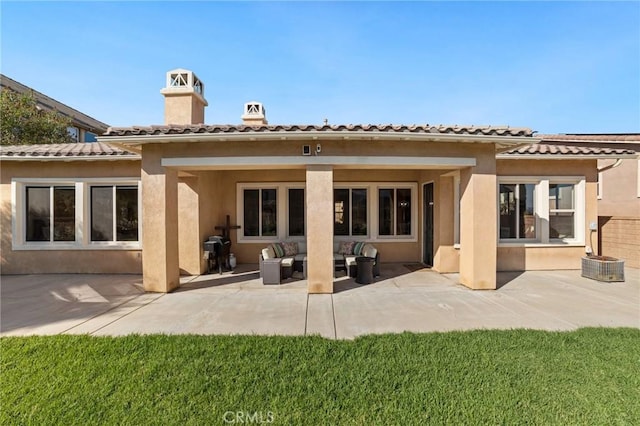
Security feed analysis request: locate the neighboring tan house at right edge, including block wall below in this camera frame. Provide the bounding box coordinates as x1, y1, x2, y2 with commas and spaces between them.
538, 133, 640, 268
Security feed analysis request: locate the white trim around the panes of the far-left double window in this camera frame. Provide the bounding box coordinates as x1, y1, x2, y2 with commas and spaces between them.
11, 178, 143, 251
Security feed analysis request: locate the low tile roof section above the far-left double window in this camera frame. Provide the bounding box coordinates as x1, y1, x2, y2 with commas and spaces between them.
0, 142, 140, 160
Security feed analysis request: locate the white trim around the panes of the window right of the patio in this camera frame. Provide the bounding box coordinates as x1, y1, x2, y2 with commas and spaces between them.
496, 176, 586, 247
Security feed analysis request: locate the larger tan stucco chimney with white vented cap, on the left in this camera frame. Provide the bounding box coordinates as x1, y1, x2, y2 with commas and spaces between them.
160, 68, 209, 125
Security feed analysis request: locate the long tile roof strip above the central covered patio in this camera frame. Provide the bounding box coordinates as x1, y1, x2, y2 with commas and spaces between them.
104, 124, 533, 137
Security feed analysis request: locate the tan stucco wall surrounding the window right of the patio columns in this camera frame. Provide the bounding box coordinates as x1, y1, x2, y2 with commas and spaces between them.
497, 160, 598, 271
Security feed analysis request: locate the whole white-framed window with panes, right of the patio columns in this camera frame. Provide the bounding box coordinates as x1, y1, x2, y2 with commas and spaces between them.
498, 177, 585, 244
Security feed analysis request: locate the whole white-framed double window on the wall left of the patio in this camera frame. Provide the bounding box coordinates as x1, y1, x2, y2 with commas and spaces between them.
11, 178, 141, 250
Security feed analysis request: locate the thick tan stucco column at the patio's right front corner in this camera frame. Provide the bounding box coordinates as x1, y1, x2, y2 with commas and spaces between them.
460, 169, 498, 290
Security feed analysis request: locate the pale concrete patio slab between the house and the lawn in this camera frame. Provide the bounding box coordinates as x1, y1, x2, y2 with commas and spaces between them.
0, 264, 640, 339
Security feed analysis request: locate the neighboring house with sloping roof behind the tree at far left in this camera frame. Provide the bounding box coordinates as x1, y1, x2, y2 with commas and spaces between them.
0, 74, 109, 142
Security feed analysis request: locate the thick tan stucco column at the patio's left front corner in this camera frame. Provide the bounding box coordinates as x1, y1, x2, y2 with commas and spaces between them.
142, 146, 180, 293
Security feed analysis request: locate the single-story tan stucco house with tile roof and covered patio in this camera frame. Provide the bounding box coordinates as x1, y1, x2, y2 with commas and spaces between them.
1, 69, 637, 293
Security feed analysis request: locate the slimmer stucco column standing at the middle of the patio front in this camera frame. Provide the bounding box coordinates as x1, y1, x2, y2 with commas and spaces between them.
306, 166, 334, 293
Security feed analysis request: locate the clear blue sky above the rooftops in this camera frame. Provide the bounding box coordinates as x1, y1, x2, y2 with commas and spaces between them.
1, 1, 640, 133
